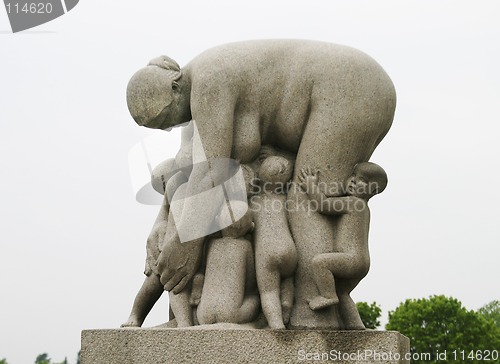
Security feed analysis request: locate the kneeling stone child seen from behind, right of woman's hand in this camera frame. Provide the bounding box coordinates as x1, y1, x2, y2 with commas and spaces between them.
197, 201, 260, 325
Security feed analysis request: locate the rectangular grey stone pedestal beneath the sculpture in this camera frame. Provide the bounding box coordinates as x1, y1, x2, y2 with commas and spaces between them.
81, 328, 410, 364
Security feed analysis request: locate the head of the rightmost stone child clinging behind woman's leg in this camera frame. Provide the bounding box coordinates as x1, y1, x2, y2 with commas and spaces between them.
347, 162, 387, 200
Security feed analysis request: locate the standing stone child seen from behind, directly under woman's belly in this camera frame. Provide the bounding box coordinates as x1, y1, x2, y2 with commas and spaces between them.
251, 155, 297, 329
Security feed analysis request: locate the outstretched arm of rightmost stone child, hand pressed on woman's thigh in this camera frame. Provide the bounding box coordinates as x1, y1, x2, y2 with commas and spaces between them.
299, 169, 353, 215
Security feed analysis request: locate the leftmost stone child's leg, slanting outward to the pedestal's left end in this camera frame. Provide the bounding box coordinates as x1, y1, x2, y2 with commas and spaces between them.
121, 274, 163, 327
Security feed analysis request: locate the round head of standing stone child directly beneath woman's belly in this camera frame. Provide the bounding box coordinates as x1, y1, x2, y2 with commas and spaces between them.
259, 156, 293, 191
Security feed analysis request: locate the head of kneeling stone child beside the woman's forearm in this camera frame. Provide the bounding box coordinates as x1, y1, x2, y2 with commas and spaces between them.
219, 201, 254, 238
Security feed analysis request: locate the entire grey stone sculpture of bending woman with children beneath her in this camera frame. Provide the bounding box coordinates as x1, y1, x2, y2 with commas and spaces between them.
127, 40, 396, 329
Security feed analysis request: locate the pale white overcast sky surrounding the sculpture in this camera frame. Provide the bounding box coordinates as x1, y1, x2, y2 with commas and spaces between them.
0, 0, 500, 364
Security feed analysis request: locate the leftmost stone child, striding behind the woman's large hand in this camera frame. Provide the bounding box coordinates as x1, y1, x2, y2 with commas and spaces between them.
121, 123, 201, 327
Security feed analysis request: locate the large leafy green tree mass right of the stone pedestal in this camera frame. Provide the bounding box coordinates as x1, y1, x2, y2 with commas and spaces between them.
386, 295, 500, 364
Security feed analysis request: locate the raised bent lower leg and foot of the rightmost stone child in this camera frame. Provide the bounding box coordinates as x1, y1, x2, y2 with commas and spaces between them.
309, 253, 342, 310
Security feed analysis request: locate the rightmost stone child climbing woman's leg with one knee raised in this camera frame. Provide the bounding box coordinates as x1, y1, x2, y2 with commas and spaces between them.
299, 162, 387, 329
